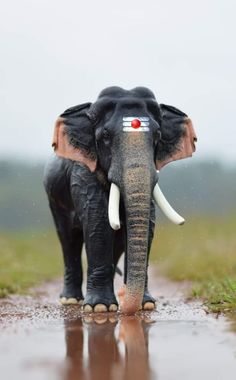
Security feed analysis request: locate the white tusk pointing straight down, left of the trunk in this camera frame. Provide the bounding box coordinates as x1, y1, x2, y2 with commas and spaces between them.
108, 183, 120, 231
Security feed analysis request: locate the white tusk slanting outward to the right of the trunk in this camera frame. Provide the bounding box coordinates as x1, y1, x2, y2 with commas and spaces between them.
153, 183, 185, 225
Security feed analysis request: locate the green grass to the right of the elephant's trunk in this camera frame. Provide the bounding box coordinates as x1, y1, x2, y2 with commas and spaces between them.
151, 217, 236, 312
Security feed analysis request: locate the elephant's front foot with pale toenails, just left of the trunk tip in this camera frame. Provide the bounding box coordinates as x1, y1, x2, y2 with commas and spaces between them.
83, 288, 118, 313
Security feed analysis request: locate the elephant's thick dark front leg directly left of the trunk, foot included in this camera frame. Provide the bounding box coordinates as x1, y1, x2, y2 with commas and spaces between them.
71, 165, 118, 312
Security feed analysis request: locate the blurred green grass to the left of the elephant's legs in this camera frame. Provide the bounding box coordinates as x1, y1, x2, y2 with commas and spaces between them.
0, 232, 63, 297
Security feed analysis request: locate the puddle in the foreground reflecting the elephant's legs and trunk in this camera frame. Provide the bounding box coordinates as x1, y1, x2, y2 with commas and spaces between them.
0, 313, 236, 380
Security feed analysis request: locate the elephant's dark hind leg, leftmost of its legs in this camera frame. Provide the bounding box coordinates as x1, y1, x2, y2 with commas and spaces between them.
50, 200, 84, 305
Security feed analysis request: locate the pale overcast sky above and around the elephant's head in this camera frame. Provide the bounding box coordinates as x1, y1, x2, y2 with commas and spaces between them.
0, 0, 236, 162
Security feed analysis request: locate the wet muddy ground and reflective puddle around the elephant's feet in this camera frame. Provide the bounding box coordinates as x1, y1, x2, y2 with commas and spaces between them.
0, 272, 236, 380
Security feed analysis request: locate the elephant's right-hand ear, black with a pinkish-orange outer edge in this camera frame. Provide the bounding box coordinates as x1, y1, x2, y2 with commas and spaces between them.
156, 104, 197, 170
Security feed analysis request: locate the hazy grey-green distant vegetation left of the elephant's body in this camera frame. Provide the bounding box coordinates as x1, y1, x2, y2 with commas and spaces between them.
0, 161, 52, 231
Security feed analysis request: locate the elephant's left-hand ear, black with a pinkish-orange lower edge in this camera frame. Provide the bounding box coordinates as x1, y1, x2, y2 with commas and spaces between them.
52, 103, 97, 172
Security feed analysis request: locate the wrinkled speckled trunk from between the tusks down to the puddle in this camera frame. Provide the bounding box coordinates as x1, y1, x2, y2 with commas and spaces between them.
121, 166, 151, 314
